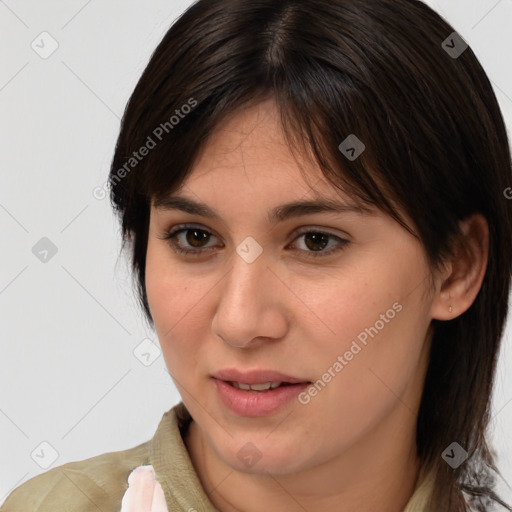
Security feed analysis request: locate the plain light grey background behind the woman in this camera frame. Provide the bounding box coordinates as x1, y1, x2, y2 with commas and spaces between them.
0, 0, 512, 503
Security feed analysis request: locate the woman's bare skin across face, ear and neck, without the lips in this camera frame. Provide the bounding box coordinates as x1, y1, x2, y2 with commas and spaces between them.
146, 100, 488, 512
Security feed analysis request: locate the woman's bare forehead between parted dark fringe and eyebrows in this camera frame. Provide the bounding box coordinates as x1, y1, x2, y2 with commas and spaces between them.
176, 100, 344, 200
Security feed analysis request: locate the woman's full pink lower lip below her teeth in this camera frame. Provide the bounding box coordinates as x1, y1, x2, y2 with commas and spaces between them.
213, 378, 309, 418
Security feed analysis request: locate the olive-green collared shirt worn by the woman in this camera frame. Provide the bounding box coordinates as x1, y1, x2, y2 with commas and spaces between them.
0, 402, 432, 512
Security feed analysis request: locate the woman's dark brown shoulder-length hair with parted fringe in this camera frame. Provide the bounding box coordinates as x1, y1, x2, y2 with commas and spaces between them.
110, 0, 512, 512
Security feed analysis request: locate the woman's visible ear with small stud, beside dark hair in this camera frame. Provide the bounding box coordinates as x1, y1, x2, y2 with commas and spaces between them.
431, 214, 489, 320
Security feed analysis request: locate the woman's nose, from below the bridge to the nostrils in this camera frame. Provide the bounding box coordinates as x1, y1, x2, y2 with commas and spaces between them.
212, 241, 290, 348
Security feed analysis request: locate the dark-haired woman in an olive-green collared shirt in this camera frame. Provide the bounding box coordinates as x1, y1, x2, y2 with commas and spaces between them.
2, 0, 512, 512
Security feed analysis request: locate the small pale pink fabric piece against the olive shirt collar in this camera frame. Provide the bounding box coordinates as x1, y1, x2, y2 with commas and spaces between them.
121, 466, 169, 512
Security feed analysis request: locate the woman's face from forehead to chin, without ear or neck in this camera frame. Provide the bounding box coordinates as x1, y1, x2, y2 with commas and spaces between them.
146, 101, 438, 474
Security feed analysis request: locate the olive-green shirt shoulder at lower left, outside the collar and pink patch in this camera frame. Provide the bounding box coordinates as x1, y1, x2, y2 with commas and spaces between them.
0, 441, 150, 512
